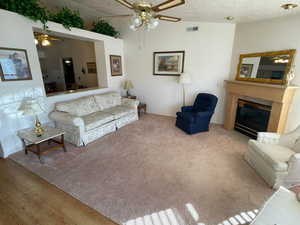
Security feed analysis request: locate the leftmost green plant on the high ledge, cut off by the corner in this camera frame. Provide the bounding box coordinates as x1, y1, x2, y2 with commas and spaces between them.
0, 0, 48, 28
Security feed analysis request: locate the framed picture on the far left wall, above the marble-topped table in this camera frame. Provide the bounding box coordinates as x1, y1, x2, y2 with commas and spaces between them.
0, 48, 32, 81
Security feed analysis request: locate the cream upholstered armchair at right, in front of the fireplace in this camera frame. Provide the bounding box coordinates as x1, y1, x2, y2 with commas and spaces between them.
245, 126, 300, 189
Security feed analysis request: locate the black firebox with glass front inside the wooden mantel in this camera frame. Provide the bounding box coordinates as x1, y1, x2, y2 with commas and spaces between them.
234, 99, 272, 138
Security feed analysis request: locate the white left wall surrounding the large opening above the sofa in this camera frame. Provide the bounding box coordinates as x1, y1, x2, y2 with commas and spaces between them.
0, 10, 126, 157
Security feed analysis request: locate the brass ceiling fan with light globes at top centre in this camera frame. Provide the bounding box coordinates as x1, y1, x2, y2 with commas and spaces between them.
116, 0, 185, 30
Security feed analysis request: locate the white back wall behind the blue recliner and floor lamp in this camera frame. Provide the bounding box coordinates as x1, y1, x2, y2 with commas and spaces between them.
119, 22, 235, 123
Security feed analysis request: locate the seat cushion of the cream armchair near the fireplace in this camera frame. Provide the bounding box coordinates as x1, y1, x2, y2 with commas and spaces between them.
249, 140, 295, 171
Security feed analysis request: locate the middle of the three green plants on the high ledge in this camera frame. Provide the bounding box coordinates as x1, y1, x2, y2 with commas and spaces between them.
49, 7, 84, 30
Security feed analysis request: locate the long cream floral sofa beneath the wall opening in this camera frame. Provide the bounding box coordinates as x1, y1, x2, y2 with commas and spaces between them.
49, 92, 139, 146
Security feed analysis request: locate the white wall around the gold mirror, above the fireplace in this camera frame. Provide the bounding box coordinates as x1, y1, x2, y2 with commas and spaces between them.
231, 15, 300, 130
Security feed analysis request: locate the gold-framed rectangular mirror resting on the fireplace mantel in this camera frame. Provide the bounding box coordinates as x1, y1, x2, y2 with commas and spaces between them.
236, 49, 296, 85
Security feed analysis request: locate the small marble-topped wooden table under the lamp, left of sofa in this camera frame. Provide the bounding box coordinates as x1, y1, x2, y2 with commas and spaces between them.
18, 126, 67, 163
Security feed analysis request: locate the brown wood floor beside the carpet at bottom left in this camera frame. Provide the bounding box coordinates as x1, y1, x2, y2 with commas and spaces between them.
0, 159, 116, 225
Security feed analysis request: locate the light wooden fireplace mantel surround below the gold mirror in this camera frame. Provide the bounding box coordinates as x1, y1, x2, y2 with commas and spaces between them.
224, 80, 299, 133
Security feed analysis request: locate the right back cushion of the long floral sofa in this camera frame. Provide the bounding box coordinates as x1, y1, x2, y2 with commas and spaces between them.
94, 92, 121, 110
